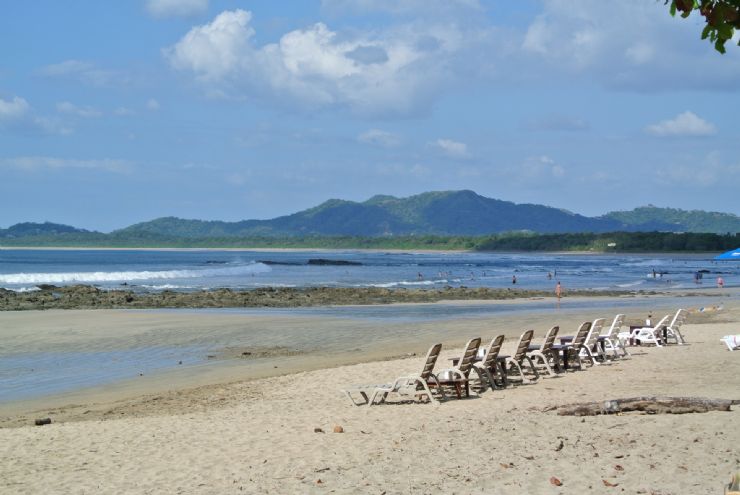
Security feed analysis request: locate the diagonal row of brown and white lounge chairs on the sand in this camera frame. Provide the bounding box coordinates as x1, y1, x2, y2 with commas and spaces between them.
342, 309, 687, 406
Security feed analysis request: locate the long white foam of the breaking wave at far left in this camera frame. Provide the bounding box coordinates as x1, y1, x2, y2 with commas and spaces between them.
0, 263, 272, 284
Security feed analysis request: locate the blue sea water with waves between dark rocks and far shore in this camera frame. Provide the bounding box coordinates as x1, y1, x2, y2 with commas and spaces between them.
0, 249, 740, 291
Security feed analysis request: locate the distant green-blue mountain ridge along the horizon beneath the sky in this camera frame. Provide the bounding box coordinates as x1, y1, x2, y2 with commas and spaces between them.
0, 190, 740, 239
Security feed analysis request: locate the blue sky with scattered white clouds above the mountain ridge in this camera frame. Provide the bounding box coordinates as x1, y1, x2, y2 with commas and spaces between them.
0, 0, 740, 232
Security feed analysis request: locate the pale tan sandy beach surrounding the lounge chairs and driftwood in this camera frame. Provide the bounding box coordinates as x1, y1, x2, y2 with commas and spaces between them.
0, 297, 740, 494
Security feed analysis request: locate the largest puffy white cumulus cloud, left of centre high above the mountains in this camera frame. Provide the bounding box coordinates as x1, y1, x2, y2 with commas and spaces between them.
163, 9, 474, 116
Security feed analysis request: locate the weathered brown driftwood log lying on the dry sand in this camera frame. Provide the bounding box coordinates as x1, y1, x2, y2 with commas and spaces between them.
546, 397, 740, 416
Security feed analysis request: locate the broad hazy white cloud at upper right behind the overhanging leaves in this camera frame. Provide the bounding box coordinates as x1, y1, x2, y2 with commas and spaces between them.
519, 0, 740, 92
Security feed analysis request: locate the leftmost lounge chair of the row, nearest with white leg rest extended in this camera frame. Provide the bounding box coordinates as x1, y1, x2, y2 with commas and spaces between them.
342, 344, 445, 406
